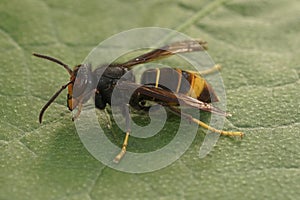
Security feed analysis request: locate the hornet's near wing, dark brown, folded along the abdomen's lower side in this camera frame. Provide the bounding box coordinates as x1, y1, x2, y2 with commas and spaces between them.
116, 81, 230, 116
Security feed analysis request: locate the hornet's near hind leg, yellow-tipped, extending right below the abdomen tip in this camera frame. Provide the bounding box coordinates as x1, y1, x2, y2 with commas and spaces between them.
169, 106, 244, 138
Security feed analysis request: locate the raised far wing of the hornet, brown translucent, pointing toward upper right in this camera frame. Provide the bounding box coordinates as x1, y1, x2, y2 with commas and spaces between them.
120, 40, 207, 68
